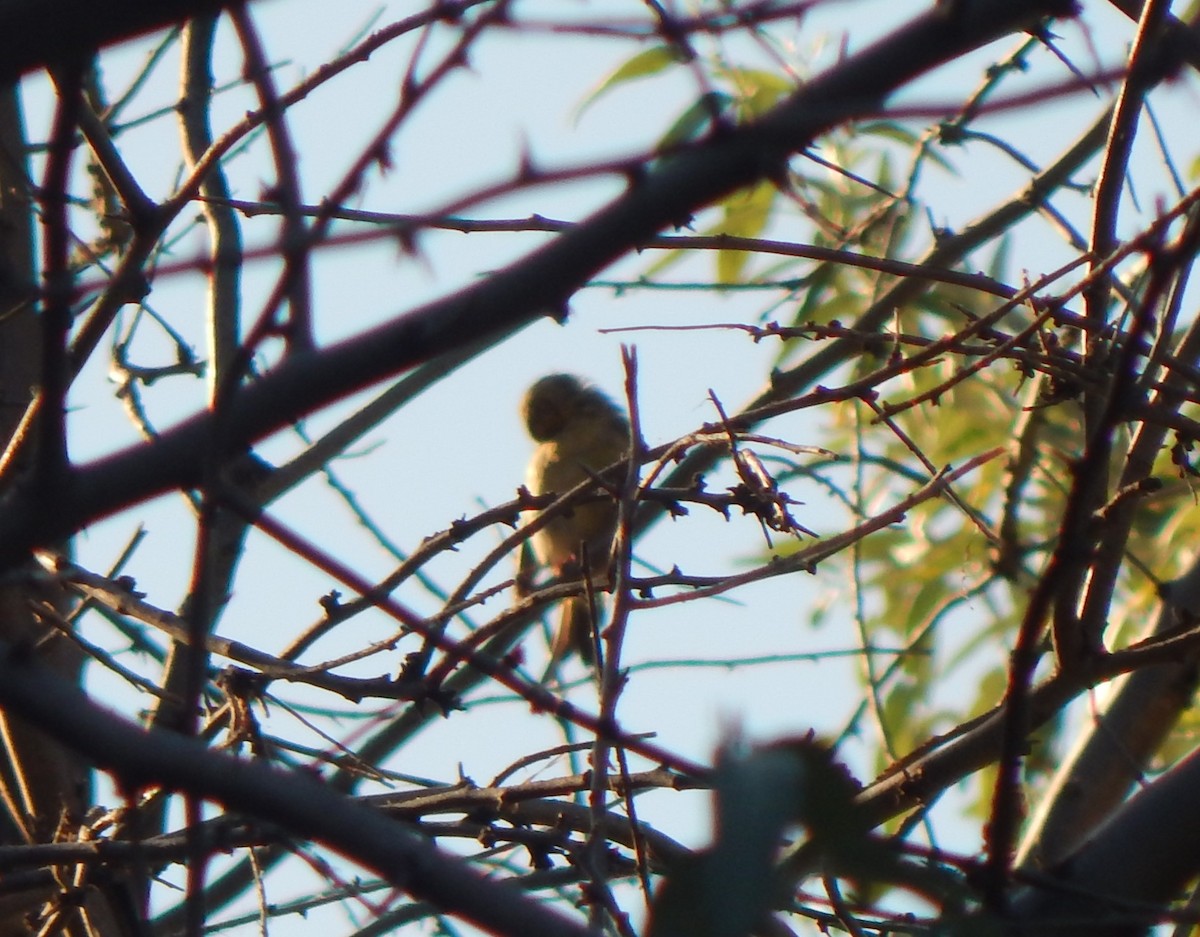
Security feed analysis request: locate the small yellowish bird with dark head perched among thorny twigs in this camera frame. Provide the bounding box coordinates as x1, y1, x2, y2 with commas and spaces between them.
521, 374, 629, 663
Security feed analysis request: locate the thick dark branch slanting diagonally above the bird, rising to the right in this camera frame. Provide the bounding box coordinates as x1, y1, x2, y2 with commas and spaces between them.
0, 0, 1074, 561
